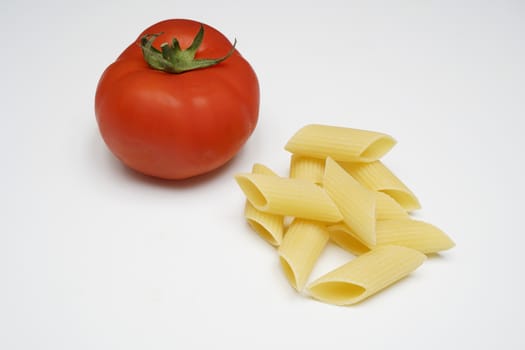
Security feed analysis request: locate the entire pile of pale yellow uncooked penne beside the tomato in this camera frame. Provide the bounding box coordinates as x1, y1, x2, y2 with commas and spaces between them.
235, 124, 454, 305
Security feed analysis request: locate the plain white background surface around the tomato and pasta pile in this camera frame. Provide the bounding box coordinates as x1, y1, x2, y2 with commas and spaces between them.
0, 0, 525, 350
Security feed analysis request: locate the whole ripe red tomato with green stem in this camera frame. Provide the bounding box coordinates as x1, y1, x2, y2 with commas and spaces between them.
95, 19, 259, 179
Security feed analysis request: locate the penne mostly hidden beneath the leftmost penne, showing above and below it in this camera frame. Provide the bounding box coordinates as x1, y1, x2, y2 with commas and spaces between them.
244, 163, 284, 246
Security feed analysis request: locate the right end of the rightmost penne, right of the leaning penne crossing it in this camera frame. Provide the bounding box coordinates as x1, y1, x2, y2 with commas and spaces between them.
376, 220, 455, 254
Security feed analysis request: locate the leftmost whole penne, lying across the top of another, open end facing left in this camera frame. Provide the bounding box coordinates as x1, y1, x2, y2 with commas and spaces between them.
235, 174, 343, 222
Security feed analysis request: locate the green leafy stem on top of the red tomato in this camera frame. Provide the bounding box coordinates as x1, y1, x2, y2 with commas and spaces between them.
140, 24, 237, 73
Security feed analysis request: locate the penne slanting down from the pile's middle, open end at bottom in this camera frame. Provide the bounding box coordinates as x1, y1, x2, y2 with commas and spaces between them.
279, 219, 329, 291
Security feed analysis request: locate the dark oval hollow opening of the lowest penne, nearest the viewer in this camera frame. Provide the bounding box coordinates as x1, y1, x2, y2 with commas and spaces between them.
310, 282, 366, 304
